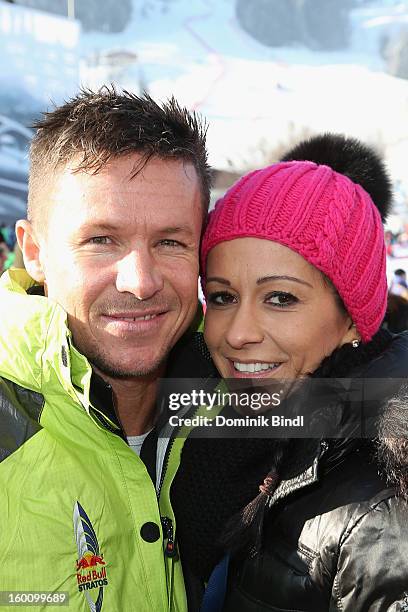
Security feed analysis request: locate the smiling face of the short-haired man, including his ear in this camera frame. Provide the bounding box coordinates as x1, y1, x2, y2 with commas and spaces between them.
27, 154, 202, 378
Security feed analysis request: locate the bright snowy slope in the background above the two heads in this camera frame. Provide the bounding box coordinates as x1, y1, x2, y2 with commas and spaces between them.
76, 0, 408, 179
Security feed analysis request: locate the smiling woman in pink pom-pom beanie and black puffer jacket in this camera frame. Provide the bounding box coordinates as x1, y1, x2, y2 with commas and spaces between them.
172, 135, 408, 612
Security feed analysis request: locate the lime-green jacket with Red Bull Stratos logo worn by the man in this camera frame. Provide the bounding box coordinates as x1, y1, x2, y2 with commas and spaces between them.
0, 270, 187, 612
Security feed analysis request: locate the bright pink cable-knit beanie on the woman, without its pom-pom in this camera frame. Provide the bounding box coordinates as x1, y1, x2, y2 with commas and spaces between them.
201, 137, 387, 342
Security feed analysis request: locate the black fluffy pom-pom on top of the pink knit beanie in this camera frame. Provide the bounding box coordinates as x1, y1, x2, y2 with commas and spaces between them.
281, 134, 392, 222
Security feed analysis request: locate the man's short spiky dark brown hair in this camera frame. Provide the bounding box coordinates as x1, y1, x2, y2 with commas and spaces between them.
27, 86, 211, 222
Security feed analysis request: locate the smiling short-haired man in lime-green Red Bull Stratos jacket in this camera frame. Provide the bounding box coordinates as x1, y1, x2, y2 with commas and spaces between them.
0, 89, 210, 612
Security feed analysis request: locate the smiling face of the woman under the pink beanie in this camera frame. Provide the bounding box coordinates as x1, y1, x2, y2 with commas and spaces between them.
205, 238, 358, 379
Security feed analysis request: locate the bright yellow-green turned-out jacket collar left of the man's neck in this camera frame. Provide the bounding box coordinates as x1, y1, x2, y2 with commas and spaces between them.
0, 269, 98, 412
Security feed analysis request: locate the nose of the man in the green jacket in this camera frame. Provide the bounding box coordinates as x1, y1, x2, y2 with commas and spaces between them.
116, 249, 164, 300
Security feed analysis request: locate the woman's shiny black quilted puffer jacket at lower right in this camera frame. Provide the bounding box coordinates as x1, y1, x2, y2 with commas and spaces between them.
224, 441, 408, 612
